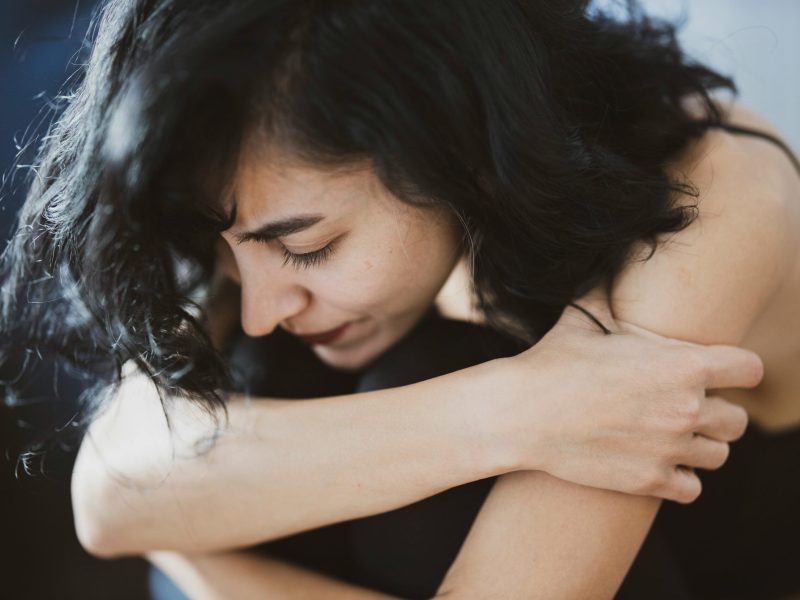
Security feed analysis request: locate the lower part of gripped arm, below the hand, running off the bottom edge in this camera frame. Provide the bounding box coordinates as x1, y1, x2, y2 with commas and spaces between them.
439, 471, 660, 600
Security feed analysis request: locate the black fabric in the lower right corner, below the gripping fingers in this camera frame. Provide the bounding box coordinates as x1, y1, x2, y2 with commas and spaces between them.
618, 424, 800, 600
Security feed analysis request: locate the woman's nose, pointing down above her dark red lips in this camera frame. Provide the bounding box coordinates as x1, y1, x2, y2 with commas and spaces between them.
238, 254, 311, 337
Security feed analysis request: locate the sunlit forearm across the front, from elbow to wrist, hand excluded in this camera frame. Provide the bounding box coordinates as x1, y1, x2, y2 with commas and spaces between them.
72, 361, 510, 556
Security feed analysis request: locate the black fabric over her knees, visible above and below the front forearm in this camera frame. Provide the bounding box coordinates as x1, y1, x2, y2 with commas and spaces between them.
150, 309, 524, 600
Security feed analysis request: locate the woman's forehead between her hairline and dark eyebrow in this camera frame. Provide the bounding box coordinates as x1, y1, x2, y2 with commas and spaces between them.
228, 143, 387, 227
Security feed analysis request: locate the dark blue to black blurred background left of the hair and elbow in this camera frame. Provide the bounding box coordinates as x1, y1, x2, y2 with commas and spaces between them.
0, 0, 149, 600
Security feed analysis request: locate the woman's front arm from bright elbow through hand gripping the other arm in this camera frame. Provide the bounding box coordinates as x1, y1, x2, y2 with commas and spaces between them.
72, 310, 761, 556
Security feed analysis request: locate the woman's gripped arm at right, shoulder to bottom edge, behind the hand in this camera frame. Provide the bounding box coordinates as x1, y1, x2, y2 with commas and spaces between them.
440, 124, 800, 600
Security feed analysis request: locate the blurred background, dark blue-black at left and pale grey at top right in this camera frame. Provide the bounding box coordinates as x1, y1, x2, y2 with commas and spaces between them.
0, 0, 800, 600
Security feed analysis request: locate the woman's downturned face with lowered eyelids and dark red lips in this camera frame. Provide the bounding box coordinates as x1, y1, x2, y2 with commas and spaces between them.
218, 145, 460, 370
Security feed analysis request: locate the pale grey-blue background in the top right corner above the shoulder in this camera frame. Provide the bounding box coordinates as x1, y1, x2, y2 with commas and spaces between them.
595, 0, 800, 152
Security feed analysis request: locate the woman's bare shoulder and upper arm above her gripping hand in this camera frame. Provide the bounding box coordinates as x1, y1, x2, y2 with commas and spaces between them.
611, 101, 800, 343
